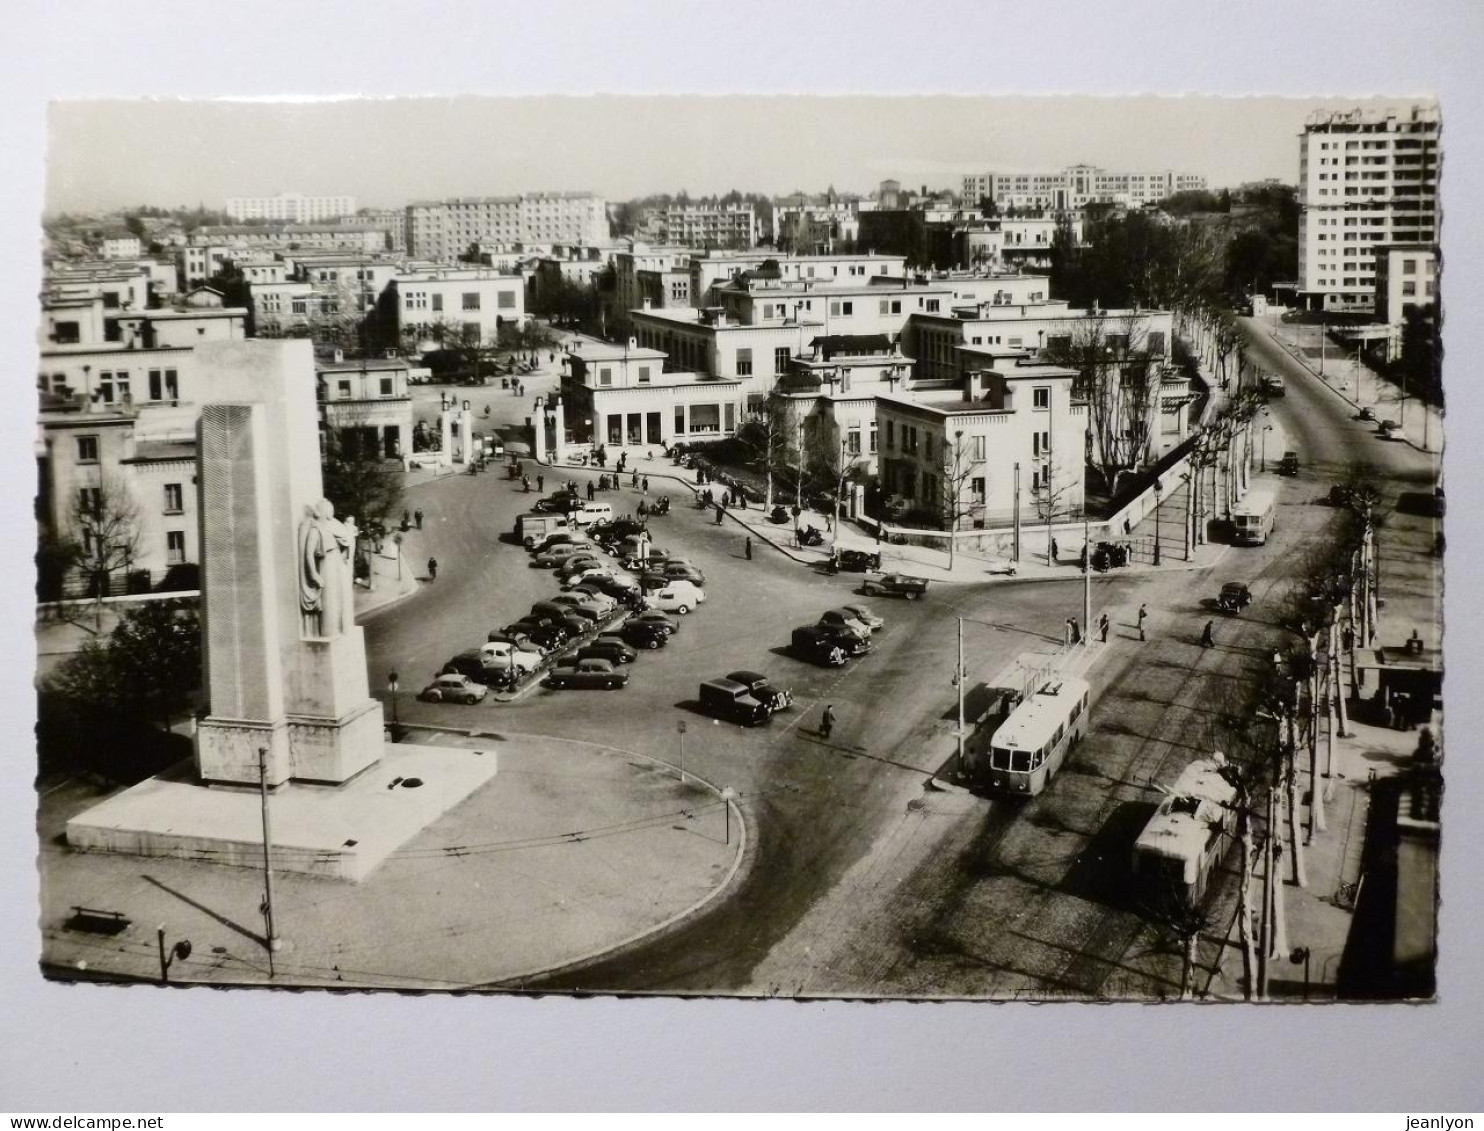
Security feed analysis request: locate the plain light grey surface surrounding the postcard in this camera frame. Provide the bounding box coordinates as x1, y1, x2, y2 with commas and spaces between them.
0, 0, 1484, 1113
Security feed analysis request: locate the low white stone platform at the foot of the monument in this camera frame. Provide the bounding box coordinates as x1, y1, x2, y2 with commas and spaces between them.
67, 739, 499, 880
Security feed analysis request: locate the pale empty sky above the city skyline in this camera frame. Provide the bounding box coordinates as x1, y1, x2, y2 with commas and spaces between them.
46, 95, 1411, 212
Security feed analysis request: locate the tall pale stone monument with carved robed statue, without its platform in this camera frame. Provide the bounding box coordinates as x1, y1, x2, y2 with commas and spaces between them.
196, 340, 383, 785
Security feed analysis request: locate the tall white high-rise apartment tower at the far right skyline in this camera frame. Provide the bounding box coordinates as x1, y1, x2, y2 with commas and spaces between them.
1299, 105, 1439, 312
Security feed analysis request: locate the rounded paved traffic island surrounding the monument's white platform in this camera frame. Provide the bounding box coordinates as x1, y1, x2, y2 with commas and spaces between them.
40, 727, 746, 990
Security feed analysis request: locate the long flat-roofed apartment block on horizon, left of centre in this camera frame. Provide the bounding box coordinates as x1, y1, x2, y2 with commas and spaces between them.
404, 193, 608, 263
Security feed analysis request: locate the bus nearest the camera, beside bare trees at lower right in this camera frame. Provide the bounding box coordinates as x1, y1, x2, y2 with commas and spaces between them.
1134, 754, 1236, 907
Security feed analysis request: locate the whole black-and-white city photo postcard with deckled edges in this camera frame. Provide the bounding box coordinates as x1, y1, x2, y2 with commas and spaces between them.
36, 96, 1448, 1003
